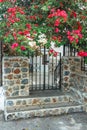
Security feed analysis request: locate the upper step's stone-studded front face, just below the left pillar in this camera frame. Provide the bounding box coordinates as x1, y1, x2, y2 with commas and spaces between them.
5, 95, 73, 111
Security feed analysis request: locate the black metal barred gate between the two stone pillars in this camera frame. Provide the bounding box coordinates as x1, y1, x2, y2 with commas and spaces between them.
29, 47, 61, 90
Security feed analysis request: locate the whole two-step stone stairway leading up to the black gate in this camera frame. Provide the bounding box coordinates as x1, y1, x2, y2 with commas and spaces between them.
4, 92, 85, 121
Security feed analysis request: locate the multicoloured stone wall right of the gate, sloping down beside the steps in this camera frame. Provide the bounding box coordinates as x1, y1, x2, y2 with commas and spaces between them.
62, 57, 87, 104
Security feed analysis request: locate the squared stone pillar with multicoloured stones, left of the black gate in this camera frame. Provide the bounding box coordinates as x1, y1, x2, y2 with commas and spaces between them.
3, 57, 29, 98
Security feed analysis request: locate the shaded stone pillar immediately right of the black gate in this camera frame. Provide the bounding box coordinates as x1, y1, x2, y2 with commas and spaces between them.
62, 56, 81, 91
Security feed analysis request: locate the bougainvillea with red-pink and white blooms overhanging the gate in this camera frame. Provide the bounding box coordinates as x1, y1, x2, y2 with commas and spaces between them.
0, 0, 87, 55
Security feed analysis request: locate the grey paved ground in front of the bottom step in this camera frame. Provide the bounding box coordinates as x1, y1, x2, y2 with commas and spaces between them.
0, 113, 87, 130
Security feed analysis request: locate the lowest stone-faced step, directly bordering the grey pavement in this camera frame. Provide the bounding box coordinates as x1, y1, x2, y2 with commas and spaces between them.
4, 104, 85, 121
